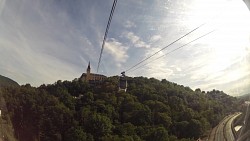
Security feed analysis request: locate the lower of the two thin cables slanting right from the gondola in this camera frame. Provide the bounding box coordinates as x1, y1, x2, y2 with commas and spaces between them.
131, 29, 215, 72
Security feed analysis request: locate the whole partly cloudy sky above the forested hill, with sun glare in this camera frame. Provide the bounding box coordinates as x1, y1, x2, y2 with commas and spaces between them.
0, 0, 250, 96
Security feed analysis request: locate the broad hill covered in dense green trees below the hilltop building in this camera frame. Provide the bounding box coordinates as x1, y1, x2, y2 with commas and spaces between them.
2, 77, 241, 141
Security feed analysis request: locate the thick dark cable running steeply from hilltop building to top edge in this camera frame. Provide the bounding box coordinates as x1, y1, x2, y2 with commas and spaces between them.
97, 0, 117, 73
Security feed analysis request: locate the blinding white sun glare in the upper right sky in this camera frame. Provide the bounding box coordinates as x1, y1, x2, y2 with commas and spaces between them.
189, 0, 250, 74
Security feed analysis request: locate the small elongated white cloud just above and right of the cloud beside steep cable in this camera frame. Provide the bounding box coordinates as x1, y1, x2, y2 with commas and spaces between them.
122, 32, 150, 48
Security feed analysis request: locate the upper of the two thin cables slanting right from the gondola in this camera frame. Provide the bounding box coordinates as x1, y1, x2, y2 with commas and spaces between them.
125, 23, 206, 72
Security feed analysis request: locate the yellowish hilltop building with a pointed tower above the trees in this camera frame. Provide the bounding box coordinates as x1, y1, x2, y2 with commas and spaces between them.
80, 62, 107, 83
